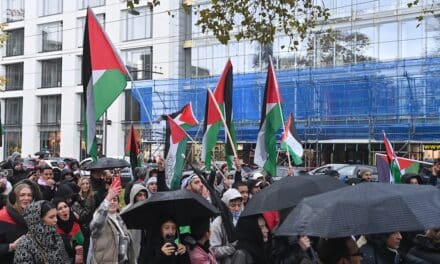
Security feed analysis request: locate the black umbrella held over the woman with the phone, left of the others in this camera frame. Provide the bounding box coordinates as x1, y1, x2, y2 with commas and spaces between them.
121, 190, 218, 229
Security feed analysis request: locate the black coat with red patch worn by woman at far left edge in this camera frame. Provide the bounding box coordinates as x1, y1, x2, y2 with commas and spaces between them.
0, 205, 27, 264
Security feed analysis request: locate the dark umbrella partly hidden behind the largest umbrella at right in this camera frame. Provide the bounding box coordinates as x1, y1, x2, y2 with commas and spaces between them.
241, 175, 346, 216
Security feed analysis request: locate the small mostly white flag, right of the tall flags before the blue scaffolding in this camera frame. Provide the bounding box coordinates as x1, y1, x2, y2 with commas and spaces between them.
281, 113, 304, 166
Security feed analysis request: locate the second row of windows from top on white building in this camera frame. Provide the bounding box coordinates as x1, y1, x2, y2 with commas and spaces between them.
4, 7, 152, 57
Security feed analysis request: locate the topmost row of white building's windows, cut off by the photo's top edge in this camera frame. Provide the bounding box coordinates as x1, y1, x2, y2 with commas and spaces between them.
2, 0, 105, 22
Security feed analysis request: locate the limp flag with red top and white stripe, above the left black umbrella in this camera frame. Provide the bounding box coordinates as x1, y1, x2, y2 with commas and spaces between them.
165, 116, 187, 190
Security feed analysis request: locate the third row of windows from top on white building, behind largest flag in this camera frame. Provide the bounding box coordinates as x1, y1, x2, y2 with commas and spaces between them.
4, 47, 153, 91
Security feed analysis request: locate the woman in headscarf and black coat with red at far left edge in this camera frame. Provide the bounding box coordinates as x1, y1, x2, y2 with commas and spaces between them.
0, 180, 41, 264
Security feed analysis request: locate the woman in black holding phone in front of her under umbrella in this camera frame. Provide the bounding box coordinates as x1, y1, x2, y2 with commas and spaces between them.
153, 218, 191, 264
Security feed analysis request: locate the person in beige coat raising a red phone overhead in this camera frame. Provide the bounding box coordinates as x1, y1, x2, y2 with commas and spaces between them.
87, 184, 137, 264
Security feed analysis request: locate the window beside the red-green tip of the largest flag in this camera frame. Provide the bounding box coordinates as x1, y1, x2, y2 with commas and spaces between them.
122, 47, 153, 80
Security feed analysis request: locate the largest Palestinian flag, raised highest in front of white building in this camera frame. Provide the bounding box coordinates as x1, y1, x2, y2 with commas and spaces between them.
82, 8, 128, 158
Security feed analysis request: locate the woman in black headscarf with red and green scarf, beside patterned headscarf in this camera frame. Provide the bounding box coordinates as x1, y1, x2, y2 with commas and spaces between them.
53, 199, 84, 264
